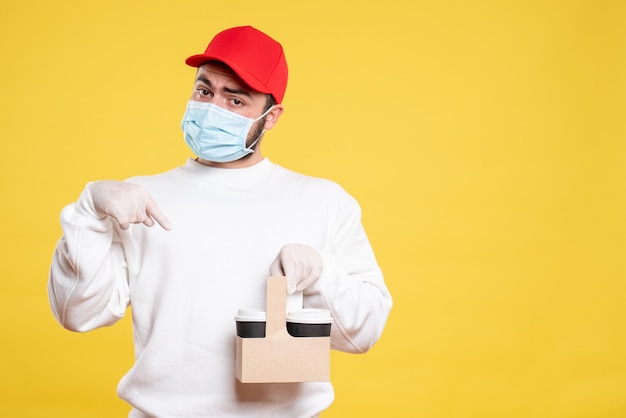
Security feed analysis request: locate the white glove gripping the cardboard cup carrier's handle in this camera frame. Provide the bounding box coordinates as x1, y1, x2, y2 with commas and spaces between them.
270, 244, 323, 294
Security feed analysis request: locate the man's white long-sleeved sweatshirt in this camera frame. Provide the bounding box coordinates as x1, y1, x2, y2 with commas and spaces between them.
49, 159, 392, 418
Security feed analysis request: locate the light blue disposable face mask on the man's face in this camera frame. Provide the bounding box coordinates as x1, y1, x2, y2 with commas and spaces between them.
182, 100, 272, 163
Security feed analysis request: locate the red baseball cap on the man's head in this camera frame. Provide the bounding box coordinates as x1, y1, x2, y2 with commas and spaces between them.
185, 26, 287, 103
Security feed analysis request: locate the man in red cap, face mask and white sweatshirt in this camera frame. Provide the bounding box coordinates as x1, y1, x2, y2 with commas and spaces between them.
49, 26, 392, 418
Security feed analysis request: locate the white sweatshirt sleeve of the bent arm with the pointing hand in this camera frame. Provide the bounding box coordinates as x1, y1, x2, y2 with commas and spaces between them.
48, 183, 129, 332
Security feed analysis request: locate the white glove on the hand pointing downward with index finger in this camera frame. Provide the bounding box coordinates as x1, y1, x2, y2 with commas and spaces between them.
89, 180, 172, 231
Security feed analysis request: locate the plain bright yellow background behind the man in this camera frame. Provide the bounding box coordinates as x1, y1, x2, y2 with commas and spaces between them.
0, 0, 626, 418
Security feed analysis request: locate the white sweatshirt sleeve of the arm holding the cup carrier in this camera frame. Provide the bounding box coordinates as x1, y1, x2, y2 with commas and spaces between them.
305, 193, 392, 353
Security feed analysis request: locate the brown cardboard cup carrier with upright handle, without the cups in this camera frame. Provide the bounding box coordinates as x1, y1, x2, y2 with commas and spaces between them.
235, 277, 330, 383
